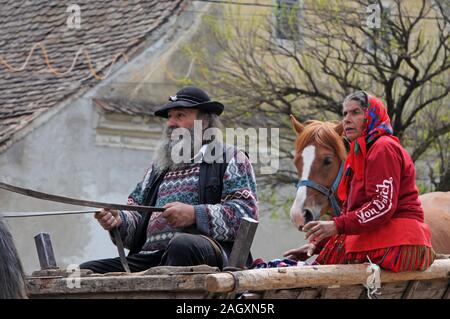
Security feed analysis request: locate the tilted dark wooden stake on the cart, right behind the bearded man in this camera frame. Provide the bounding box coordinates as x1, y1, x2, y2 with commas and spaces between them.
228, 217, 258, 269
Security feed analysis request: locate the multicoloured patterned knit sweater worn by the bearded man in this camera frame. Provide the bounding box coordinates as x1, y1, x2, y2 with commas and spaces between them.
114, 152, 259, 253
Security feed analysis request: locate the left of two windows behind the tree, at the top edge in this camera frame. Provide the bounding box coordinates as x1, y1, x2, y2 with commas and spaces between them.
275, 0, 303, 40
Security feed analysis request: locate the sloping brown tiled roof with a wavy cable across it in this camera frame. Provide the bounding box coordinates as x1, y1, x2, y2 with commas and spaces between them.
0, 0, 184, 152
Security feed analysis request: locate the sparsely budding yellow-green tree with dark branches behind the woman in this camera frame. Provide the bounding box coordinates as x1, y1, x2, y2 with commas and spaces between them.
181, 0, 450, 200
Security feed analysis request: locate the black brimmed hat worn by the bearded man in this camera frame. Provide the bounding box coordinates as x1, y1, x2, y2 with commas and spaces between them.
155, 86, 224, 117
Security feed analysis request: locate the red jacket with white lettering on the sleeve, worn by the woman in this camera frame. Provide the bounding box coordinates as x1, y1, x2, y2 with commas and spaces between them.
334, 136, 424, 235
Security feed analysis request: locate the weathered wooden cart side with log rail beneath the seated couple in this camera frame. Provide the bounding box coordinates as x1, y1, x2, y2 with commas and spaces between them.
27, 258, 450, 299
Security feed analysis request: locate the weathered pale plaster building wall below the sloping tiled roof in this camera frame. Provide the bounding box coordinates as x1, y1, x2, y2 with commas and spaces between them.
0, 0, 301, 273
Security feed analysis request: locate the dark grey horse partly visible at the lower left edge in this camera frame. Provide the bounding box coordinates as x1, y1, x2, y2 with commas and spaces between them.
0, 216, 27, 299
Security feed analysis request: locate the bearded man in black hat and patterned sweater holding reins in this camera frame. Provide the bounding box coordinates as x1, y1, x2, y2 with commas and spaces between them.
80, 87, 259, 273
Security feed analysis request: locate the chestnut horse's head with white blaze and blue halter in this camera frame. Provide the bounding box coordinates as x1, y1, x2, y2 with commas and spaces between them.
291, 115, 347, 229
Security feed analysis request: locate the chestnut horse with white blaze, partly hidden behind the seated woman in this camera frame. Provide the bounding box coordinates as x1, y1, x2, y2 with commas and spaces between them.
290, 116, 450, 254
